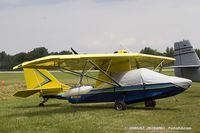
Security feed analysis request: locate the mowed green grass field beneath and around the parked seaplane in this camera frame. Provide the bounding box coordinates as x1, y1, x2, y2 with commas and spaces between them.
0, 71, 200, 133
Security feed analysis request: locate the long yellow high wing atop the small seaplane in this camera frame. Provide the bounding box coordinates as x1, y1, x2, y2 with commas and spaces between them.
13, 53, 175, 94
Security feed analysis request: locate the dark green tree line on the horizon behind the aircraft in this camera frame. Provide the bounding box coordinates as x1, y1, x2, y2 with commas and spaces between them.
0, 47, 200, 70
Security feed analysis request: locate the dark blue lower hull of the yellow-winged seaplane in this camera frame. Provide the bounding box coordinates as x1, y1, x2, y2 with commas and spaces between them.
65, 83, 185, 104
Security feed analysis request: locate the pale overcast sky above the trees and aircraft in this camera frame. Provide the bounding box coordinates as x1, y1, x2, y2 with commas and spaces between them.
0, 0, 200, 54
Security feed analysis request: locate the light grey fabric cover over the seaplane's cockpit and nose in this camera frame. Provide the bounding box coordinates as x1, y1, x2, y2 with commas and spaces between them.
111, 68, 191, 88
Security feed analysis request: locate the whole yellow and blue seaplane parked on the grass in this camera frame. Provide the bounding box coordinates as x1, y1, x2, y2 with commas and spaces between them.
13, 49, 191, 110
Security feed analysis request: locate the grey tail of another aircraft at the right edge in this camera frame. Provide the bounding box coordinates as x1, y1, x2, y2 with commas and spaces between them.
174, 40, 200, 81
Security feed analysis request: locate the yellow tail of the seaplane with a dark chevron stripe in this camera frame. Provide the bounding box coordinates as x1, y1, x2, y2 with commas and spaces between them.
14, 68, 70, 97
